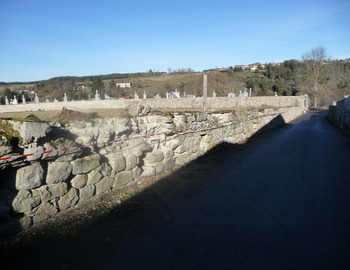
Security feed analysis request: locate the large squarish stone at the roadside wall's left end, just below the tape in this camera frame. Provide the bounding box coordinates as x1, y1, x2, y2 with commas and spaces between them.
16, 162, 44, 190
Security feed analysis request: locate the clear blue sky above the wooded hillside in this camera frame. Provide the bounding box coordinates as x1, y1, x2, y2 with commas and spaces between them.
0, 0, 350, 82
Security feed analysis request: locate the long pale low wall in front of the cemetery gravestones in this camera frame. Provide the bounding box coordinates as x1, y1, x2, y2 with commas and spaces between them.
0, 96, 305, 113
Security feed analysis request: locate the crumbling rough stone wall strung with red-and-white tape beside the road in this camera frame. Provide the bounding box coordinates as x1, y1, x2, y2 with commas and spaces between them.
0, 101, 302, 236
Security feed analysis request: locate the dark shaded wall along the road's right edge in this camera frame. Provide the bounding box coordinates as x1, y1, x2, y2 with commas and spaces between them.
328, 96, 350, 134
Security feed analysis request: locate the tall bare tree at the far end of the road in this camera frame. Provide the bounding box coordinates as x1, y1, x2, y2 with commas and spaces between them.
302, 46, 329, 107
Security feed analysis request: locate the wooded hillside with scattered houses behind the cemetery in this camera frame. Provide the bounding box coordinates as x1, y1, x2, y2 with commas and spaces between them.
0, 60, 350, 107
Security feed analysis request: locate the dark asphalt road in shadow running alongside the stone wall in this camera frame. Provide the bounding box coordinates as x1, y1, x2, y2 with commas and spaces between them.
0, 112, 350, 269
